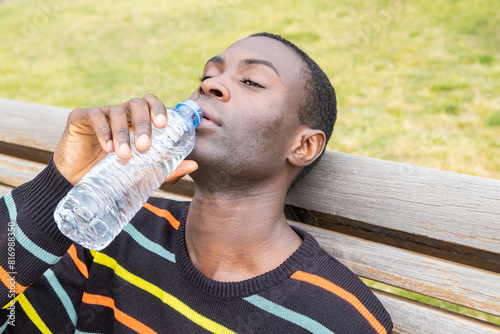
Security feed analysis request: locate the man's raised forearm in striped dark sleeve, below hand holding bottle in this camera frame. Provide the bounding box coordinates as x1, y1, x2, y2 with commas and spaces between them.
0, 162, 72, 307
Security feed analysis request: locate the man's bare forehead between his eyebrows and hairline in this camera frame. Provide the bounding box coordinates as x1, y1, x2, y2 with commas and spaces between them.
209, 36, 304, 82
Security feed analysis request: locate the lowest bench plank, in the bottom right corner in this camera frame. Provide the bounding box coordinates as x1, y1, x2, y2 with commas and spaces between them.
373, 290, 500, 334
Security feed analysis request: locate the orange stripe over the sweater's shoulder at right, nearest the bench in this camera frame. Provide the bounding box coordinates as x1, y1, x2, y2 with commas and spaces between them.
292, 271, 387, 334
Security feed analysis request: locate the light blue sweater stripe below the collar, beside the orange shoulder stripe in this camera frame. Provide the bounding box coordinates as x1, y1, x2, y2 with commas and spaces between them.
243, 295, 334, 334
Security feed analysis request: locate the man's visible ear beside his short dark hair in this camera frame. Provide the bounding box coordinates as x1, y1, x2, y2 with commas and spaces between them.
288, 125, 326, 167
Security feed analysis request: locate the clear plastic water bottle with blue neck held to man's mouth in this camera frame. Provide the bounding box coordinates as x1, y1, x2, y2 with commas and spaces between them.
54, 100, 202, 250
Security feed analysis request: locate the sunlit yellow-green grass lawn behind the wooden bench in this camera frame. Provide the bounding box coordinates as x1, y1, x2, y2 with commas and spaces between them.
0, 0, 500, 322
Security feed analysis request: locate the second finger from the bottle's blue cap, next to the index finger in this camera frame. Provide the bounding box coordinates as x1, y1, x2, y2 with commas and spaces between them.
127, 98, 151, 152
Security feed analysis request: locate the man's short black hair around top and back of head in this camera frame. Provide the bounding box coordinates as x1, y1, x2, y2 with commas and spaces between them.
249, 32, 337, 187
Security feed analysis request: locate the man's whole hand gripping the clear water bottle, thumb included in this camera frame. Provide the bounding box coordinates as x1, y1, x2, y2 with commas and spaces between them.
54, 94, 198, 185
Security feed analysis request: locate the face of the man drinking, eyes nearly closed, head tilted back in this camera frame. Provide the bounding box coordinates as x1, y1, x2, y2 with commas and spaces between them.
189, 37, 303, 189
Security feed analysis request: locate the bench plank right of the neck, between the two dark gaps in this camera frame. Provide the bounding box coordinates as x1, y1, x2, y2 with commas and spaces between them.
290, 222, 500, 316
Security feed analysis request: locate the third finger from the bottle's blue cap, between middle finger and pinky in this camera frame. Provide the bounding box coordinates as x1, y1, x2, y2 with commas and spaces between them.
108, 106, 132, 159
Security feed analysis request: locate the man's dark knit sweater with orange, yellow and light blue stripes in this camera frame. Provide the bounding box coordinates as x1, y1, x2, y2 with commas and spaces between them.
0, 163, 392, 334
